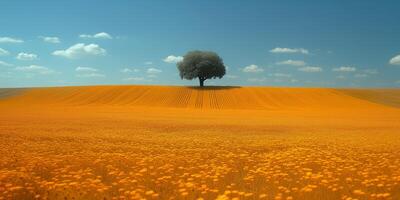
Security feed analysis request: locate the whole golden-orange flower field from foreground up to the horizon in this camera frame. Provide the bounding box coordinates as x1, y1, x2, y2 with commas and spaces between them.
0, 86, 400, 200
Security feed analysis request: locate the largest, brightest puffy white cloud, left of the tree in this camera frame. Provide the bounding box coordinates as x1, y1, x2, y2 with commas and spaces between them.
52, 43, 106, 58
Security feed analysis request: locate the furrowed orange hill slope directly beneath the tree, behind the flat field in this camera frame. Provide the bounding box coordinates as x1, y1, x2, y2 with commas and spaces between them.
0, 86, 400, 110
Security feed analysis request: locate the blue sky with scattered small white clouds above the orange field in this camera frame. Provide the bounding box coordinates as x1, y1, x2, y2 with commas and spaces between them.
0, 0, 400, 87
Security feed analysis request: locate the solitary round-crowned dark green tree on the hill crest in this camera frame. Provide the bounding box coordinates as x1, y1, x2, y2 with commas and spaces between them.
177, 51, 225, 87
